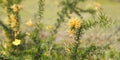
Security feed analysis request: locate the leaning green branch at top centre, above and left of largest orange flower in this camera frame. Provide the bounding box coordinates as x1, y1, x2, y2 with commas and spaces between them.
53, 0, 87, 34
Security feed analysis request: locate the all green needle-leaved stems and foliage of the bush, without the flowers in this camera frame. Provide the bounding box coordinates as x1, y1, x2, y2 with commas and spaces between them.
0, 0, 120, 60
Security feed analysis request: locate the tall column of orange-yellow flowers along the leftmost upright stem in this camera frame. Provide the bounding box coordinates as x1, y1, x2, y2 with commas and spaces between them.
3, 0, 22, 32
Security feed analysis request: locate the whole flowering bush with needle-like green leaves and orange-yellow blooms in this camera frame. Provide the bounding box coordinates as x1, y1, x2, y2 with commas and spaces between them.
0, 0, 120, 60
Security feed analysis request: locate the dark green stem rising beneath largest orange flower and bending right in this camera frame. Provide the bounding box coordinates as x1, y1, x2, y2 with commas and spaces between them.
71, 10, 113, 60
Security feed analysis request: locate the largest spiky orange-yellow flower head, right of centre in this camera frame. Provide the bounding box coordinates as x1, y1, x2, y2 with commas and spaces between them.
68, 18, 80, 29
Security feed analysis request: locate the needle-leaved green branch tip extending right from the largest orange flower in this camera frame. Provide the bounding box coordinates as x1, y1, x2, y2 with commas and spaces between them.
81, 13, 111, 30
